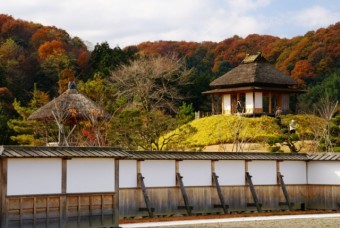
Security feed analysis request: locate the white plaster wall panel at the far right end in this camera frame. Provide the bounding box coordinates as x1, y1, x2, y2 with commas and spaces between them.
307, 161, 340, 185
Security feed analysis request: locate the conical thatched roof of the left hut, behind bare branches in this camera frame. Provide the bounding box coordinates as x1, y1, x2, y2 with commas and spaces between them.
28, 83, 110, 120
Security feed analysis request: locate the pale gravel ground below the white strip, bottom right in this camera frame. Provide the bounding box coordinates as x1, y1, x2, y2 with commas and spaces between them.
167, 217, 340, 228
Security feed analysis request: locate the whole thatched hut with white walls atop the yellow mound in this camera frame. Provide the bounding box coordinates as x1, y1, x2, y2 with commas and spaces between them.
204, 53, 302, 115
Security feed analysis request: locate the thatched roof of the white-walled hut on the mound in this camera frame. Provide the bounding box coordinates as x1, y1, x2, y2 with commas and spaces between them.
210, 53, 297, 87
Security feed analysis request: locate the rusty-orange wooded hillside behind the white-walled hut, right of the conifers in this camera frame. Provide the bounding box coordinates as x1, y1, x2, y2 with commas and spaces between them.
136, 22, 340, 87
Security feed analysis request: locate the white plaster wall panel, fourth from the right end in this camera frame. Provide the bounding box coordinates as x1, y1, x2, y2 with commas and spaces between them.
215, 160, 245, 186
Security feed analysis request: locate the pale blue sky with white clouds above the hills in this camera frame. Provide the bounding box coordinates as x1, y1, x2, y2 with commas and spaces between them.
0, 0, 340, 47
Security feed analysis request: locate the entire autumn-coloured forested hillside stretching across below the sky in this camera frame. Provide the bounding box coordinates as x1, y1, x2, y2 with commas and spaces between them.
0, 14, 340, 110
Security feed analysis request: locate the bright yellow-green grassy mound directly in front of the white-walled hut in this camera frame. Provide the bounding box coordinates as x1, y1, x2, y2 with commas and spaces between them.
168, 115, 280, 148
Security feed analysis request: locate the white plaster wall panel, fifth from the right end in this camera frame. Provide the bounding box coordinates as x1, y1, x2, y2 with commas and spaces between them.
179, 160, 211, 186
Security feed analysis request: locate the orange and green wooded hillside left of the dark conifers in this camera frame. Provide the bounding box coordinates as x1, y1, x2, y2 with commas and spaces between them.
0, 14, 90, 103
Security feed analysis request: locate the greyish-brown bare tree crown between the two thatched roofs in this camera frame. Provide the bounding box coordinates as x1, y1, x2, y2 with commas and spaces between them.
110, 57, 192, 113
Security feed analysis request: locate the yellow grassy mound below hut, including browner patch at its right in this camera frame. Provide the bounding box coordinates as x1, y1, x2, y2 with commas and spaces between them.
166, 115, 324, 149
